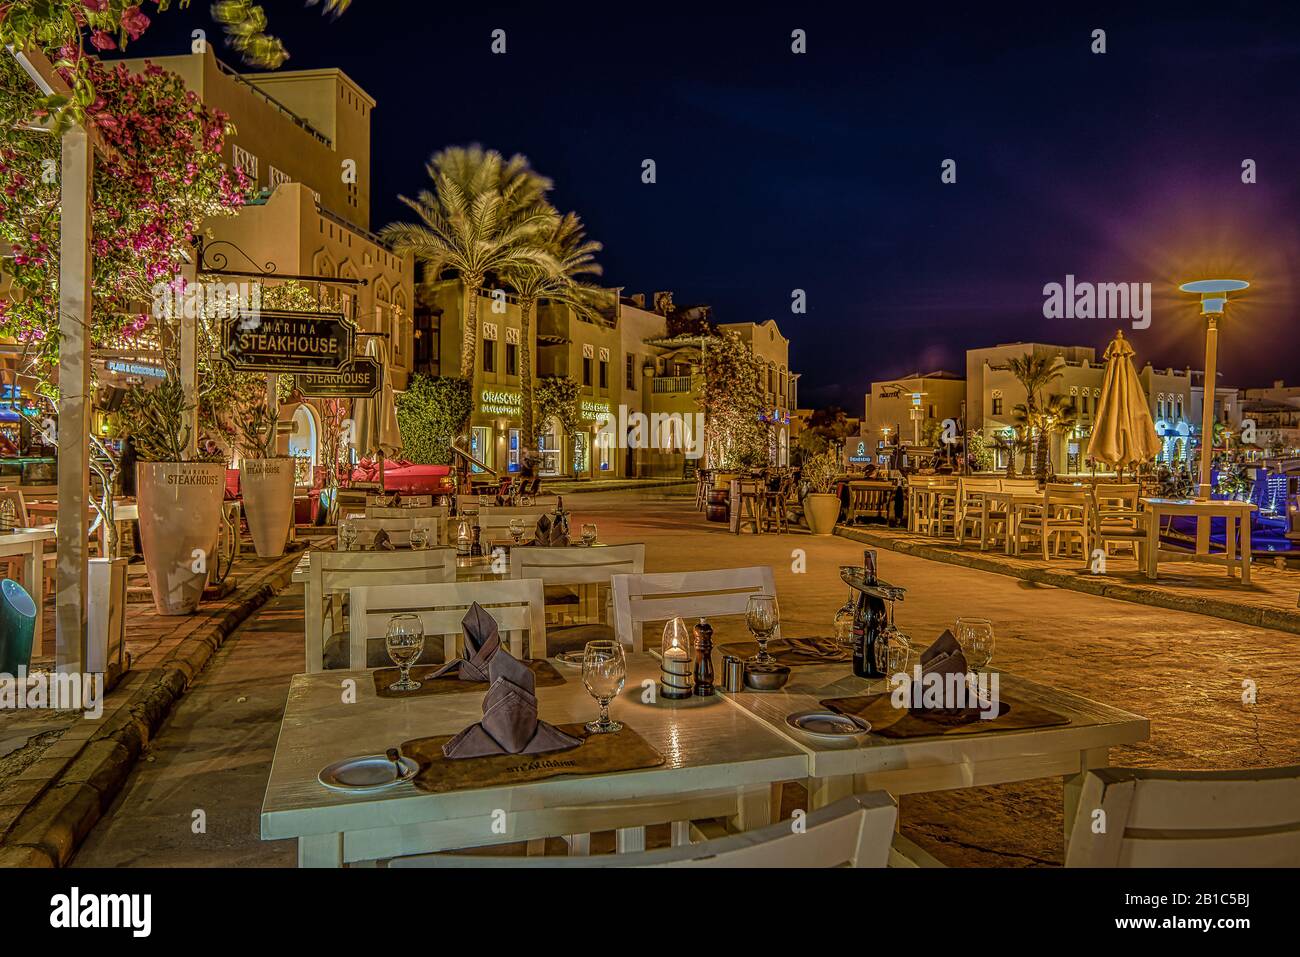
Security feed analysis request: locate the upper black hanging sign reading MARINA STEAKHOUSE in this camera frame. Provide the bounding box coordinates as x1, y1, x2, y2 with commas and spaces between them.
221, 309, 356, 372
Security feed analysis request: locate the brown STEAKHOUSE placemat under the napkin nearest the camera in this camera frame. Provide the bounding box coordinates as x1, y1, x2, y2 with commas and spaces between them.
402, 724, 664, 794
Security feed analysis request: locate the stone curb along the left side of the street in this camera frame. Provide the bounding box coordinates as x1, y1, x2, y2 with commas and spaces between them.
0, 551, 300, 867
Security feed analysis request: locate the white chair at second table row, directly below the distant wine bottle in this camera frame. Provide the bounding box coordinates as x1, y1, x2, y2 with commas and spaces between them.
510, 544, 646, 654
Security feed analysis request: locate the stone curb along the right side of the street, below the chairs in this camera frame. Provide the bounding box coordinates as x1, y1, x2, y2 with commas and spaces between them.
835, 525, 1300, 635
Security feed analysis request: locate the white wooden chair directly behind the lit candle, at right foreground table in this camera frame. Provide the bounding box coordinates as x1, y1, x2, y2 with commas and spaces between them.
611, 564, 781, 651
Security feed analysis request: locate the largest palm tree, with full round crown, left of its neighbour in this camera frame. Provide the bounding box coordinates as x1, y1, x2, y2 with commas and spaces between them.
381, 146, 555, 379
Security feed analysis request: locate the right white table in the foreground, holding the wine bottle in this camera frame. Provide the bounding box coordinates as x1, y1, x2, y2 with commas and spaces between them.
725, 664, 1151, 835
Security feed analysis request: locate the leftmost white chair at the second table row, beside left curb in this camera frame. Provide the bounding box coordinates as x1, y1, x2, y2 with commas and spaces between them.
303, 549, 456, 674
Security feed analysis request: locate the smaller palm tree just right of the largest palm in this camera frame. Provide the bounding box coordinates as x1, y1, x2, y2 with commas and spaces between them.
502, 213, 607, 449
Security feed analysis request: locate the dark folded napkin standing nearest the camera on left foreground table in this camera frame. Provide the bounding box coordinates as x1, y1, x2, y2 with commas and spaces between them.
442, 649, 582, 758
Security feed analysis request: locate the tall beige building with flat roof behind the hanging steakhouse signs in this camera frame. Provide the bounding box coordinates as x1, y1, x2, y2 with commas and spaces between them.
116, 47, 415, 477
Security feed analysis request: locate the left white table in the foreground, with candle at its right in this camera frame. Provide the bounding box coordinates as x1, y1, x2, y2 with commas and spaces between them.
261, 653, 807, 867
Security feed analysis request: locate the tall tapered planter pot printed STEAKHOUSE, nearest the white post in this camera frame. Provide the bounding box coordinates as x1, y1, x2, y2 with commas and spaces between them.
135, 462, 226, 615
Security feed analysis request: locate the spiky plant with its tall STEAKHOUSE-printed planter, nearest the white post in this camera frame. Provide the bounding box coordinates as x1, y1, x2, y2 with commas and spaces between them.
122, 376, 226, 615
